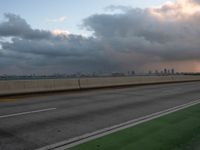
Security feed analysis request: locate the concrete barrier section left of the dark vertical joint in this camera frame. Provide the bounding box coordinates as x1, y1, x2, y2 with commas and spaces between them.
0, 79, 79, 95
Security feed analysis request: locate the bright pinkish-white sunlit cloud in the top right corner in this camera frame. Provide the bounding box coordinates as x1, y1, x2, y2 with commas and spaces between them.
148, 0, 200, 21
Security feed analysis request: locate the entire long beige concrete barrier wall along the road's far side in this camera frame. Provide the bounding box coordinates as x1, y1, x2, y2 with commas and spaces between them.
0, 76, 200, 95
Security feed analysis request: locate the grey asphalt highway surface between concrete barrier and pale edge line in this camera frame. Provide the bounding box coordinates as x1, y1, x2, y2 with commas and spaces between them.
0, 82, 200, 150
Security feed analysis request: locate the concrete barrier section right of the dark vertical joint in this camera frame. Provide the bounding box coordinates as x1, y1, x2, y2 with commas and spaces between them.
80, 76, 200, 89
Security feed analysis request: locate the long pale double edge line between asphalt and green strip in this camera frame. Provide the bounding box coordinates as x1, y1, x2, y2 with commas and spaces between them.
37, 99, 200, 150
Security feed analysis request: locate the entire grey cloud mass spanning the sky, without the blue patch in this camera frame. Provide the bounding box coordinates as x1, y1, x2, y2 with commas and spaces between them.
0, 0, 200, 73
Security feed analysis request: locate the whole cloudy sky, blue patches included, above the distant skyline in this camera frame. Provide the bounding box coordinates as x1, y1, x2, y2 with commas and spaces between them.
0, 0, 200, 74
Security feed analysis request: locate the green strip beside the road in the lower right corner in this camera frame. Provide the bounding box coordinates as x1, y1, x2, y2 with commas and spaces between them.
68, 105, 200, 150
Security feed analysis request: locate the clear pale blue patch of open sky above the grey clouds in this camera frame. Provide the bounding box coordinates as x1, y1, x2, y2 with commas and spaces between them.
0, 0, 172, 34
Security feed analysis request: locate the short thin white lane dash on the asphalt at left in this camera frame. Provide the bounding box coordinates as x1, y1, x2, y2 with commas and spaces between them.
0, 108, 56, 119
